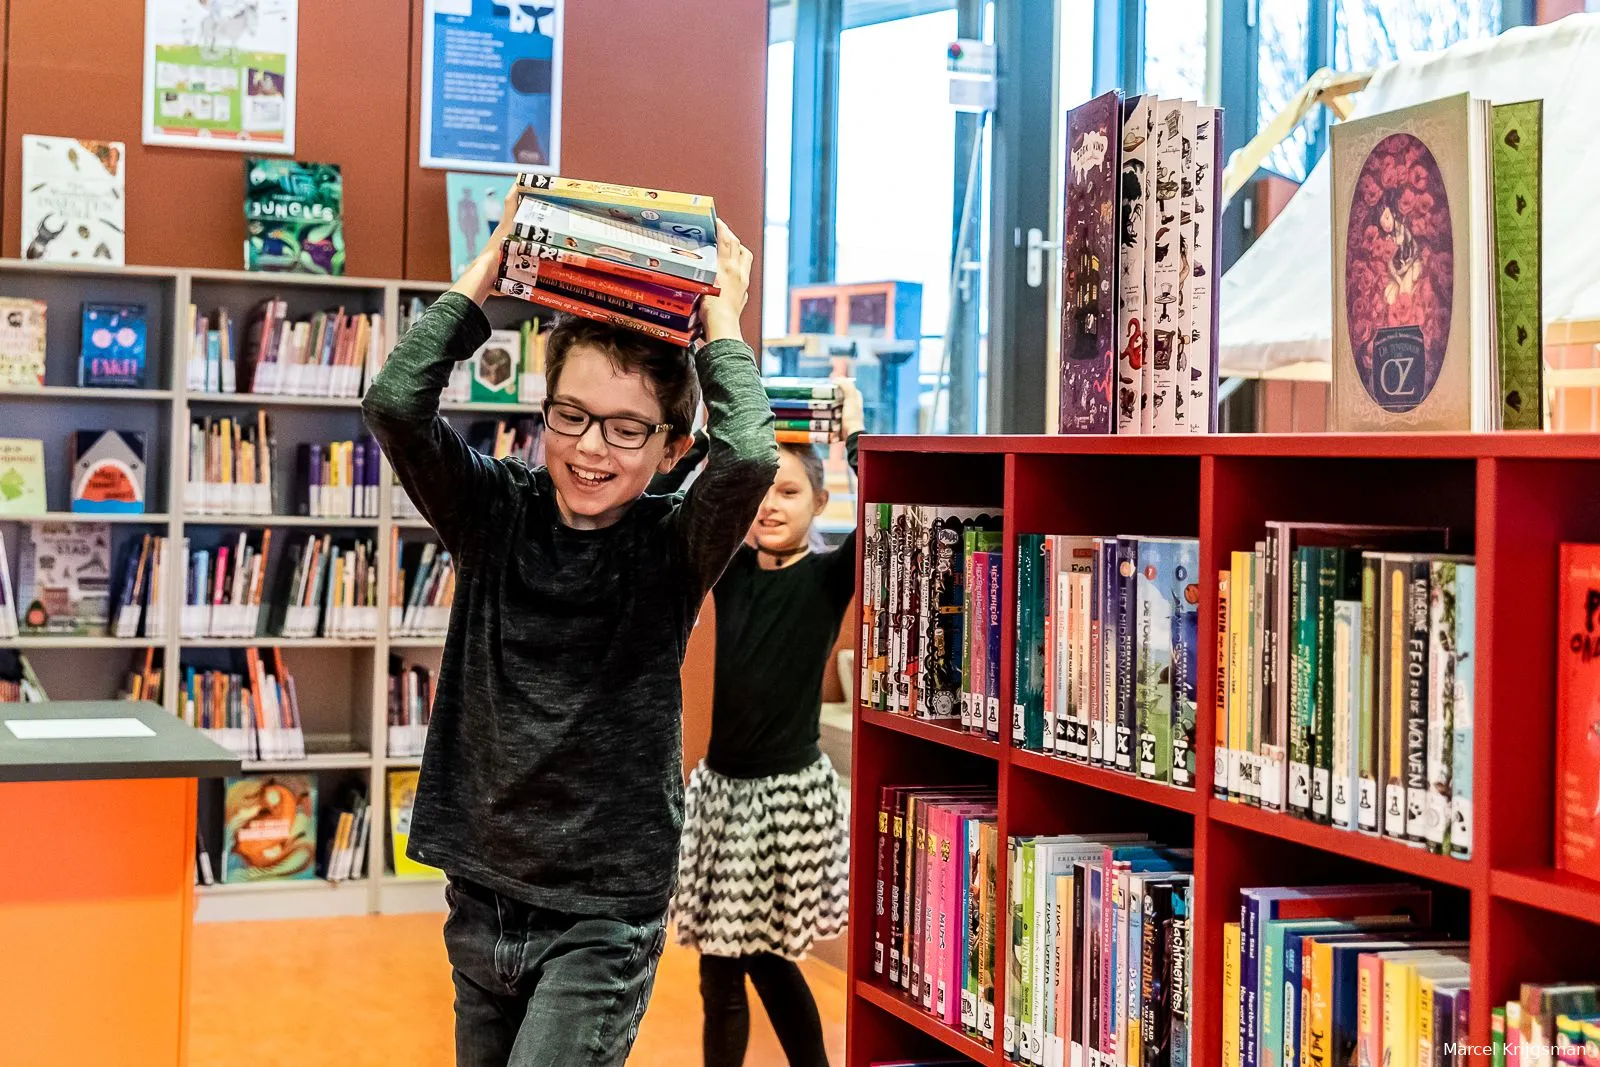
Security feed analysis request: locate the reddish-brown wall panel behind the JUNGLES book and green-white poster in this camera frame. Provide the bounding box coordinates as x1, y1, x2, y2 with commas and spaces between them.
0, 0, 411, 277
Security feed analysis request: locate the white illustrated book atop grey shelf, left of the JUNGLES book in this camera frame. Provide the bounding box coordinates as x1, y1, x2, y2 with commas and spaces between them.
21, 134, 128, 266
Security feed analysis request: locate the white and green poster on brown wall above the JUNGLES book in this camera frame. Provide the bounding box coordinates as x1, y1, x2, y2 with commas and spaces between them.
144, 0, 299, 155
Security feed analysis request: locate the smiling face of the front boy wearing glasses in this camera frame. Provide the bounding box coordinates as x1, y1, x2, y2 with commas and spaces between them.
544, 346, 691, 530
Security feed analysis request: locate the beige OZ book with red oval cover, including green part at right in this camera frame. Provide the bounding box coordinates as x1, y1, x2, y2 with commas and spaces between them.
1328, 93, 1544, 432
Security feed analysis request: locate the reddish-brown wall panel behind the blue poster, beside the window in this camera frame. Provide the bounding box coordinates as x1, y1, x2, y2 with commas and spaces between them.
405, 0, 766, 341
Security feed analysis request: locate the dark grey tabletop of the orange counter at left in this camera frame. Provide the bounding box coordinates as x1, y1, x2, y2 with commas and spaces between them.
0, 701, 240, 782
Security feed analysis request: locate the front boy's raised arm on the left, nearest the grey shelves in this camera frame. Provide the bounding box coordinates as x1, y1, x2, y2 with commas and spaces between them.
362, 230, 502, 553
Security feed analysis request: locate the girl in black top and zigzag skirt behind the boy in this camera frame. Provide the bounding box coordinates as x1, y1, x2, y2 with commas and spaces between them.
658, 382, 862, 1067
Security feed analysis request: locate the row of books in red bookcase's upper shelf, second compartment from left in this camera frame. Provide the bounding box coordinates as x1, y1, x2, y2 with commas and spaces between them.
1011, 534, 1200, 789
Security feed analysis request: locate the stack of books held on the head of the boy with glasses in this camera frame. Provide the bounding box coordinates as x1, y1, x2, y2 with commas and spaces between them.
494, 174, 718, 347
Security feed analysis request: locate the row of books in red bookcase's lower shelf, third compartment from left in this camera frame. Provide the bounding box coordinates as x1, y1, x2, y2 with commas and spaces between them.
1222, 885, 1467, 1067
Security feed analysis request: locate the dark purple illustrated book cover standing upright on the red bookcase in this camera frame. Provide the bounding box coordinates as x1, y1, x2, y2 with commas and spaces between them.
1059, 90, 1122, 434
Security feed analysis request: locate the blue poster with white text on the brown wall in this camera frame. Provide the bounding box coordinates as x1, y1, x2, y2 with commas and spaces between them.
419, 0, 563, 174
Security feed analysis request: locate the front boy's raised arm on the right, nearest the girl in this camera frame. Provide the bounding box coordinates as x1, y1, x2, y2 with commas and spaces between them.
674, 221, 778, 593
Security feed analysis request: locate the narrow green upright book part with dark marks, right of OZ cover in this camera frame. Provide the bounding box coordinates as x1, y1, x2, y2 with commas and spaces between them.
1491, 101, 1544, 430
